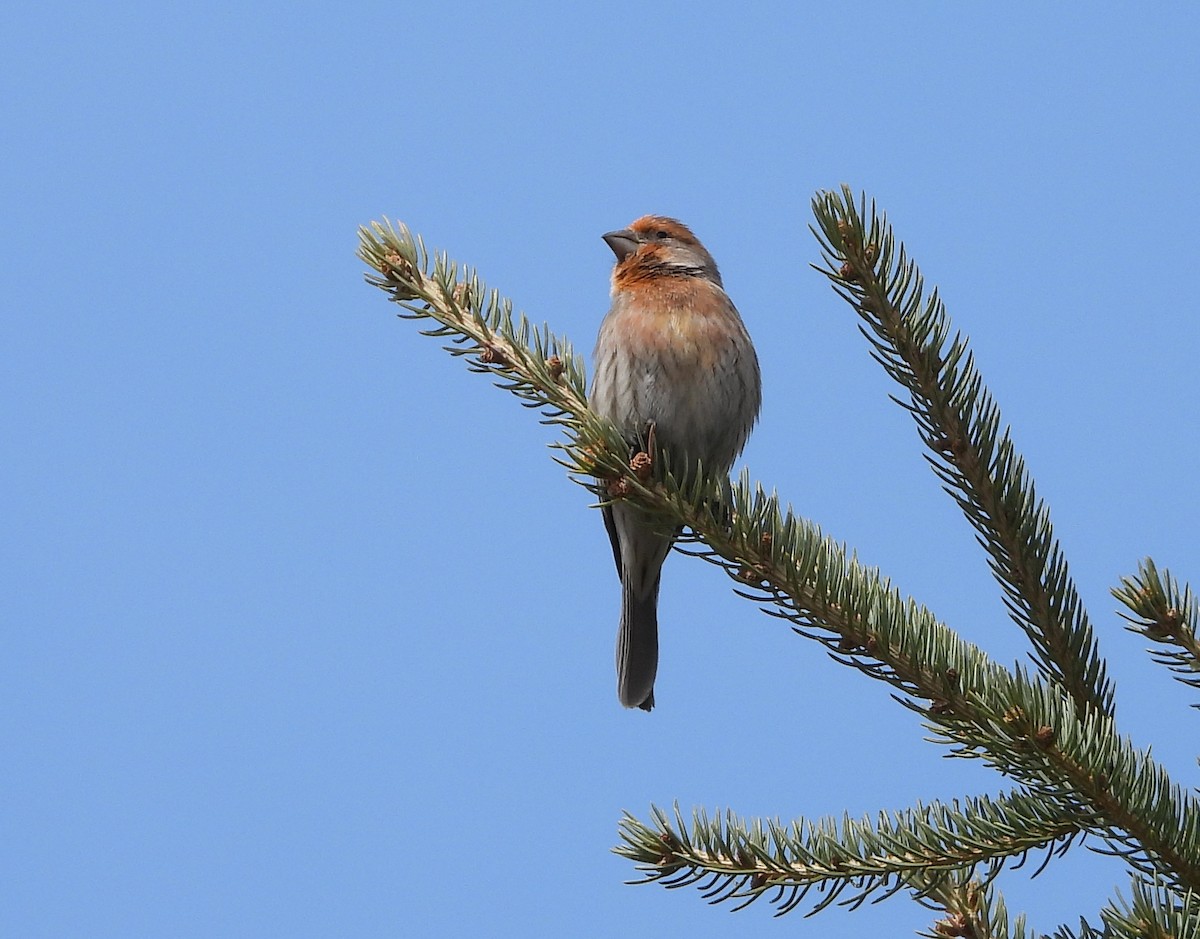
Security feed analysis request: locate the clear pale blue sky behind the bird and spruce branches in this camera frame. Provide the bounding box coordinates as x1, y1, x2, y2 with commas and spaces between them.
7, 2, 1200, 937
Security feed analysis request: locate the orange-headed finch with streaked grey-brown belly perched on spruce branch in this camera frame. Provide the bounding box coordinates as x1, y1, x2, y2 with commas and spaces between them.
588, 215, 762, 711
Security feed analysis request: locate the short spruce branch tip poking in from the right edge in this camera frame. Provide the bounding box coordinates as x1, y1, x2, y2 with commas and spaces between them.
1112, 557, 1200, 707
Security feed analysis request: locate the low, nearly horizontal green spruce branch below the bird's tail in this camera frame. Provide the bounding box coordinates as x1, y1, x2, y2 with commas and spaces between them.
613, 793, 1080, 917
